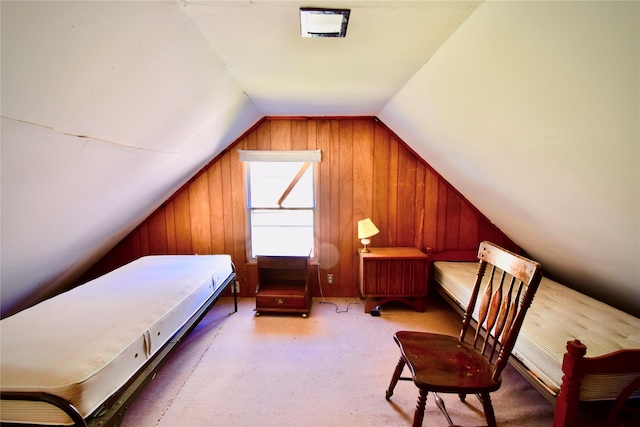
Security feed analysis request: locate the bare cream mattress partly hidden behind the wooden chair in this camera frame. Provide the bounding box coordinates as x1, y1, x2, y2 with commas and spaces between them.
433, 261, 640, 401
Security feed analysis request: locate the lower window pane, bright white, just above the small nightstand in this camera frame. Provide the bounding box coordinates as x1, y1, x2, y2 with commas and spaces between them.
251, 209, 313, 257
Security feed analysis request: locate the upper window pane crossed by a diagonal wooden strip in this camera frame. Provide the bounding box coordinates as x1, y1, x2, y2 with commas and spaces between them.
249, 162, 313, 208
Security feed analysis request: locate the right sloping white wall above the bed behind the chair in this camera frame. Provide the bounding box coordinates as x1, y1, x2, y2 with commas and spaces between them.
379, 1, 640, 315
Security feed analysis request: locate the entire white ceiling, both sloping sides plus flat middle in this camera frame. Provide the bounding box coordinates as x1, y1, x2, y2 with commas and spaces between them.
0, 0, 640, 316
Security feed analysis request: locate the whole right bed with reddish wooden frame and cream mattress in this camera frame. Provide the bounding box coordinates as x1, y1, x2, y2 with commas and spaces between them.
429, 251, 640, 427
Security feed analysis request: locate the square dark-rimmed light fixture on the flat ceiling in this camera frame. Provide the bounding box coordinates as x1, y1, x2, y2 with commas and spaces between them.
300, 7, 351, 37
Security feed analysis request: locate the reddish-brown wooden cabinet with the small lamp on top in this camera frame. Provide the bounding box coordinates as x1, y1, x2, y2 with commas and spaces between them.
359, 247, 428, 312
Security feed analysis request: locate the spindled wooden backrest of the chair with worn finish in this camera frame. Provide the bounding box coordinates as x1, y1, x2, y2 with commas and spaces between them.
460, 242, 542, 380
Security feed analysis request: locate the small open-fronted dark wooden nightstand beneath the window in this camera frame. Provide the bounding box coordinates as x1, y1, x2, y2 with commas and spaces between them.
256, 256, 311, 317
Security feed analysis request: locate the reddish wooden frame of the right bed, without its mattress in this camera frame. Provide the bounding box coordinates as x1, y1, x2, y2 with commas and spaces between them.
426, 248, 640, 427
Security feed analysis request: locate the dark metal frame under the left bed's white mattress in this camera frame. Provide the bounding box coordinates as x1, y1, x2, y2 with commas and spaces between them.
0, 267, 238, 427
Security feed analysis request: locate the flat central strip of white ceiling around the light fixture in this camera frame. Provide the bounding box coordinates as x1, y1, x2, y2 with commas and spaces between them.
185, 1, 480, 116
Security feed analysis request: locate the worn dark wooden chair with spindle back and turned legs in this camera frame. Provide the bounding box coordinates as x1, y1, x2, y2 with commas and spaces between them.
386, 242, 542, 427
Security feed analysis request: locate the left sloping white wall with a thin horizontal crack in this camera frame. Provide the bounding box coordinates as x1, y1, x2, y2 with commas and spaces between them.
1, 2, 261, 315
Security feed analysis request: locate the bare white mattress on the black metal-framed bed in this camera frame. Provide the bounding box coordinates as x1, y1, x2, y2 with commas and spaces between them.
0, 255, 233, 425
